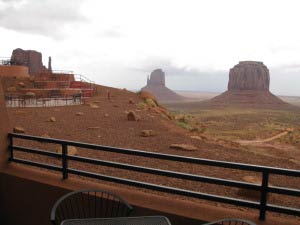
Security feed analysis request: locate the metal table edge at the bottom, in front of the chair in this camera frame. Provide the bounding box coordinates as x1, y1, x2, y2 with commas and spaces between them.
61, 216, 171, 225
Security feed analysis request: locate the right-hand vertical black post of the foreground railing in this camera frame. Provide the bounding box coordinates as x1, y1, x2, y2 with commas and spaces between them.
259, 170, 269, 220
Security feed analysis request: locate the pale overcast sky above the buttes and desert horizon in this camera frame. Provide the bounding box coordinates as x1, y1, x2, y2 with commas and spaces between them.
0, 0, 300, 96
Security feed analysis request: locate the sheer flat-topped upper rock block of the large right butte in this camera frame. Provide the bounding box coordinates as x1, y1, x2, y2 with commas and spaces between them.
228, 61, 270, 91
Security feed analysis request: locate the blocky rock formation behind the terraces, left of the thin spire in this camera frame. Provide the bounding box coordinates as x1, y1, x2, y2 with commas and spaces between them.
11, 48, 47, 75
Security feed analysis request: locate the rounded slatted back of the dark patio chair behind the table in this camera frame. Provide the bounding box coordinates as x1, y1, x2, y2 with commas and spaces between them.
51, 190, 132, 225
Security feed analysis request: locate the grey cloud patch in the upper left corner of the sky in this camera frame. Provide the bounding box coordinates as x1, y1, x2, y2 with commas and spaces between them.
0, 0, 86, 38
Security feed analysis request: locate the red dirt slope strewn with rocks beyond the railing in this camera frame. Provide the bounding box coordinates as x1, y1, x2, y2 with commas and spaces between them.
8, 86, 300, 221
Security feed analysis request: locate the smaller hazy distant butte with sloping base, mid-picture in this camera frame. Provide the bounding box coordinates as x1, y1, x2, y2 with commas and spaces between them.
142, 69, 184, 102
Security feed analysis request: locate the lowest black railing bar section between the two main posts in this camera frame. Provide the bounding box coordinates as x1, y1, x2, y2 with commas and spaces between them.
67, 168, 259, 209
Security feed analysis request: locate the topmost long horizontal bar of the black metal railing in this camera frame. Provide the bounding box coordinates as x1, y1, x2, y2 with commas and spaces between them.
9, 133, 300, 177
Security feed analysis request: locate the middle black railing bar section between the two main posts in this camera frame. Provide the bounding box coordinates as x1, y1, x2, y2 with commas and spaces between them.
68, 156, 261, 190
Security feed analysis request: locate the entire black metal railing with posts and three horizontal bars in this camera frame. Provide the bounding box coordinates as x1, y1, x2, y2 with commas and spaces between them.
8, 133, 300, 220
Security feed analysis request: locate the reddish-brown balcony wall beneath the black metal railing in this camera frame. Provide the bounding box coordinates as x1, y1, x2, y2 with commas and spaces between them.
0, 163, 299, 225
